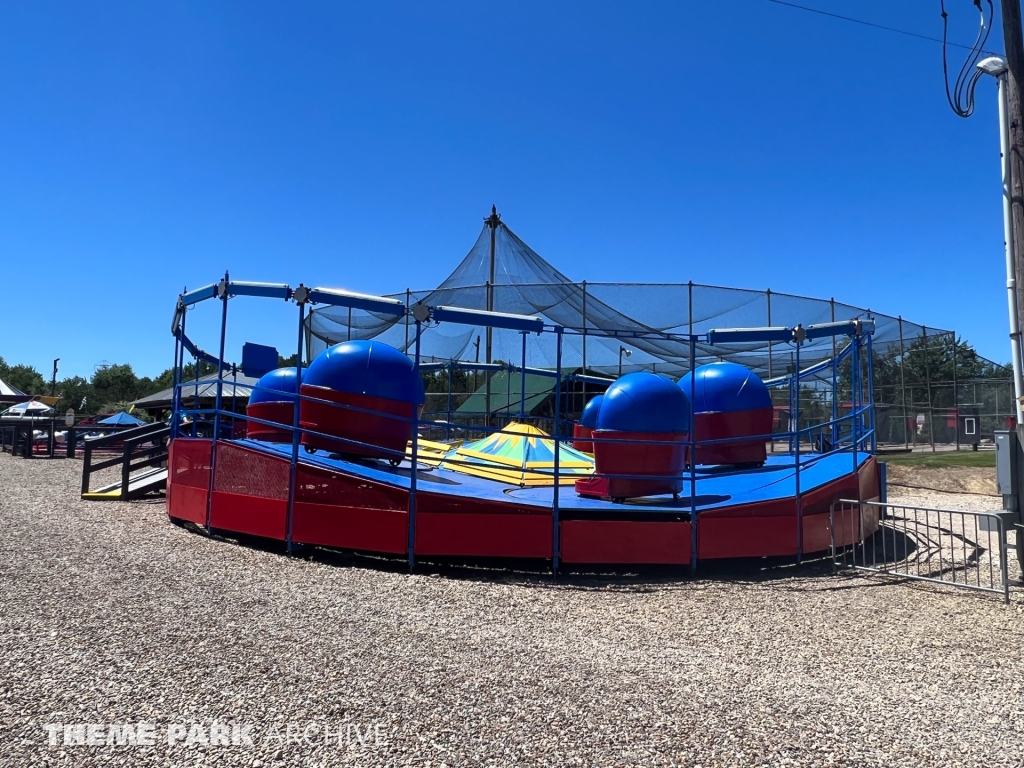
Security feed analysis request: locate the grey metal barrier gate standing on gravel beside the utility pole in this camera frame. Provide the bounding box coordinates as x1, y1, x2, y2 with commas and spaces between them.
830, 499, 1010, 602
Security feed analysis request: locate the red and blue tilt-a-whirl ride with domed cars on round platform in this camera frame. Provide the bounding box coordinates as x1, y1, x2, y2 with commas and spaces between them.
159, 275, 884, 570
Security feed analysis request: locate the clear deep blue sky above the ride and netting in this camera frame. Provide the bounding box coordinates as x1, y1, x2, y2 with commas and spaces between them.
0, 0, 1009, 376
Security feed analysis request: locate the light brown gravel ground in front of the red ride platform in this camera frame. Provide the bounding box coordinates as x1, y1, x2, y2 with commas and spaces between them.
0, 455, 1024, 768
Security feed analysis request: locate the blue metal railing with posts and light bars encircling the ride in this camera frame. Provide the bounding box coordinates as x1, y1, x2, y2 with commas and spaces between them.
172, 273, 876, 571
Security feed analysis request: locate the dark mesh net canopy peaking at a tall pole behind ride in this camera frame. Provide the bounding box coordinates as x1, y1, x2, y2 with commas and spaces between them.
306, 221, 952, 378
